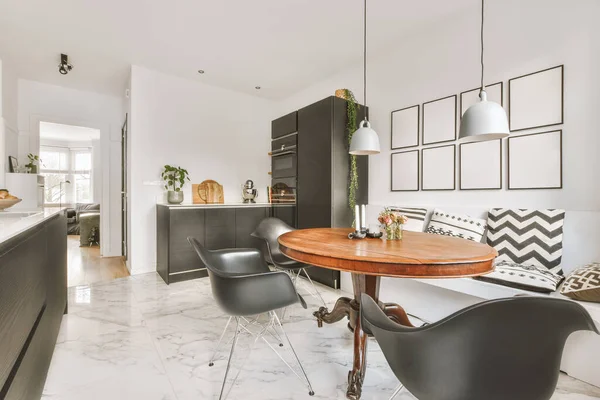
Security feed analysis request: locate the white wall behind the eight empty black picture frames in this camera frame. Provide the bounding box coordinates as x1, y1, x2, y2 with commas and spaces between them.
279, 0, 600, 289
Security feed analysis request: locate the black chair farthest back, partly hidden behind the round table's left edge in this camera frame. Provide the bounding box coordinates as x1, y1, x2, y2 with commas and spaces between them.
251, 217, 327, 307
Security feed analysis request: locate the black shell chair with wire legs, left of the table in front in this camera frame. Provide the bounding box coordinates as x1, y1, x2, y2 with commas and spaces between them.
187, 237, 314, 399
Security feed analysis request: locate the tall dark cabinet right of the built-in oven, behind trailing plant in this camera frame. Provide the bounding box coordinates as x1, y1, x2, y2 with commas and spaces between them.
286, 96, 369, 288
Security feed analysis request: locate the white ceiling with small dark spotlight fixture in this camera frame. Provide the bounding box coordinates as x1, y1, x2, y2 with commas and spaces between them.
0, 0, 480, 99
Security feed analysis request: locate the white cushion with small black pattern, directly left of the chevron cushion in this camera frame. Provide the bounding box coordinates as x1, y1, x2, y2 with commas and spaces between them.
425, 208, 486, 242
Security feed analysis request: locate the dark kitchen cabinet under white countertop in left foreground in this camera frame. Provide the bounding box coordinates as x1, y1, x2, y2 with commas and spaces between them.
0, 213, 67, 400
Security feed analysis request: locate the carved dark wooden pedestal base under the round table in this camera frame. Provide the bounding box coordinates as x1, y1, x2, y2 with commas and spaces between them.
313, 274, 413, 400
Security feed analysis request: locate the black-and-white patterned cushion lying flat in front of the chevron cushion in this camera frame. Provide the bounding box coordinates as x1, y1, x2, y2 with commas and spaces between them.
477, 261, 564, 293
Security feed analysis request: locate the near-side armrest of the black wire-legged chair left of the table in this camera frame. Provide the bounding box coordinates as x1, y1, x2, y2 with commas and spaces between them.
213, 272, 300, 315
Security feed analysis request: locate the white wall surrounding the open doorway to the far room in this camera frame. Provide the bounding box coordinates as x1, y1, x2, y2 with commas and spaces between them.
18, 79, 125, 256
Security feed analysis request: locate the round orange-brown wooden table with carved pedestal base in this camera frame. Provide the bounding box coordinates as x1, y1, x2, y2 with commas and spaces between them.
279, 228, 498, 400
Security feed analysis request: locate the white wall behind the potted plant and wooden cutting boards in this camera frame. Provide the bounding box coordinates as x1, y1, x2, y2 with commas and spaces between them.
128, 66, 273, 273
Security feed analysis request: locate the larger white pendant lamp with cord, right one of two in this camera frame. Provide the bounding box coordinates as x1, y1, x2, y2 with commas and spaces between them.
458, 0, 510, 142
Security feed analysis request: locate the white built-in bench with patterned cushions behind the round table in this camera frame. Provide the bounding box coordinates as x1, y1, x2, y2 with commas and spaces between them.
370, 204, 600, 386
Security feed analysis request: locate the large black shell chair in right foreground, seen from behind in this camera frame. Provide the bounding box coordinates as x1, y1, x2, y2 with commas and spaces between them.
360, 294, 600, 400
